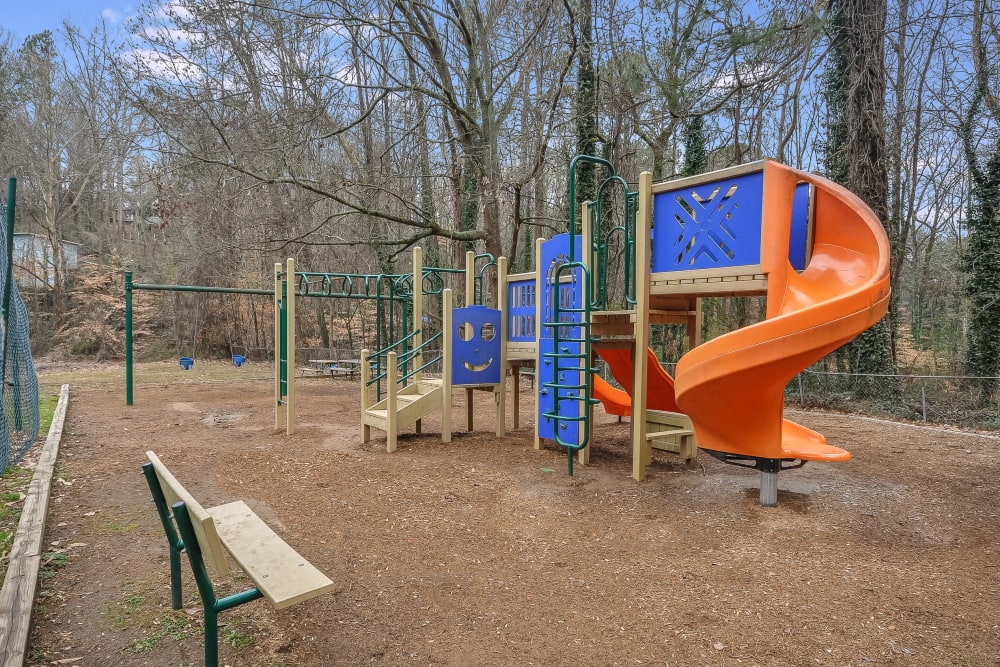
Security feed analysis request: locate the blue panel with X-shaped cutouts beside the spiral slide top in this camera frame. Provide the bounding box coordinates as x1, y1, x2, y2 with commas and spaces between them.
652, 171, 764, 273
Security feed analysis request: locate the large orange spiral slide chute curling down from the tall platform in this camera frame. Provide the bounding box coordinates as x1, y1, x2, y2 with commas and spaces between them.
675, 162, 889, 461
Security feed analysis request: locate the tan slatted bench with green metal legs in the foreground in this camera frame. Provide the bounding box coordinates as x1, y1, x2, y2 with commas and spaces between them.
142, 452, 334, 667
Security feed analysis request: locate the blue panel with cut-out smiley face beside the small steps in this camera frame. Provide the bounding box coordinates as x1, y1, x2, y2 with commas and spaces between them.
451, 306, 501, 386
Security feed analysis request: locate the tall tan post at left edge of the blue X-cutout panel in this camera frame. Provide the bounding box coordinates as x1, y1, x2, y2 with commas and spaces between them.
632, 171, 653, 481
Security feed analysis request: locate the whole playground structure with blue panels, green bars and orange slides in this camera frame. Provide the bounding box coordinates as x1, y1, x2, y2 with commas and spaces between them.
126, 156, 889, 505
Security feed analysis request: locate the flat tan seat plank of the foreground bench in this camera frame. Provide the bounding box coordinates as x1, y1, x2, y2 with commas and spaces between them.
208, 500, 334, 609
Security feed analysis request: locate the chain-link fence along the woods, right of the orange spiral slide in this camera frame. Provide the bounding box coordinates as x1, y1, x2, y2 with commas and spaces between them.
785, 369, 1000, 430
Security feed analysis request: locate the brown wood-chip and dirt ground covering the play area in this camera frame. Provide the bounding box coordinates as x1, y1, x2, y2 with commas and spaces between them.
21, 364, 1000, 667
